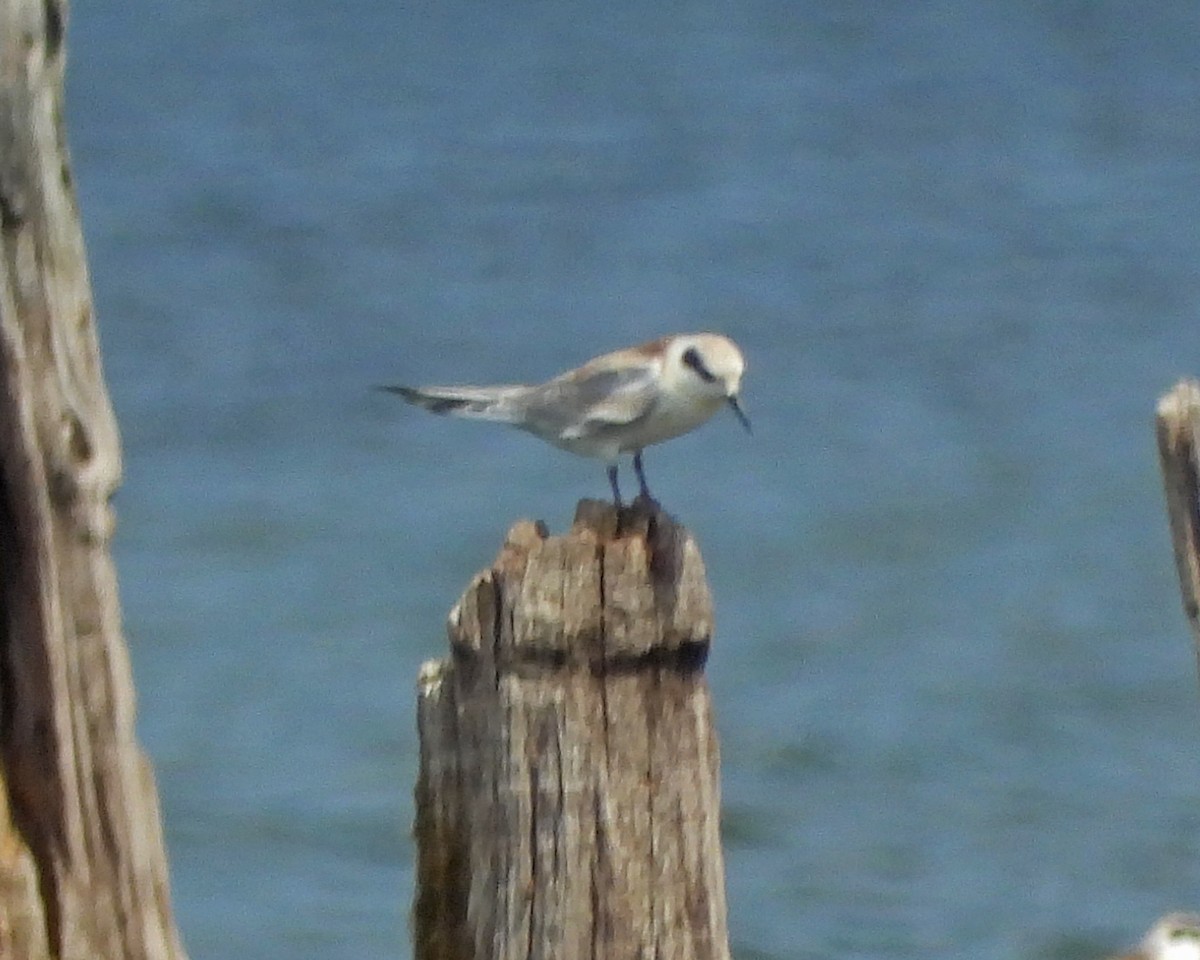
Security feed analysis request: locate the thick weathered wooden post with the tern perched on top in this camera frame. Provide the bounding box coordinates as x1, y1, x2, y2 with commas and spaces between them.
413, 500, 730, 960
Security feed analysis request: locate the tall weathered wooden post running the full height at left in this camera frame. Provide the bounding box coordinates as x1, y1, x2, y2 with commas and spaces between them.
0, 0, 184, 960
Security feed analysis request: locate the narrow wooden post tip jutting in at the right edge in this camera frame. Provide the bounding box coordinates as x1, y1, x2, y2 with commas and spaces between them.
1157, 380, 1200, 660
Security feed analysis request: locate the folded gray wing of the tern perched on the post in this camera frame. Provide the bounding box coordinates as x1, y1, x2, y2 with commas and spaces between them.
524, 366, 658, 440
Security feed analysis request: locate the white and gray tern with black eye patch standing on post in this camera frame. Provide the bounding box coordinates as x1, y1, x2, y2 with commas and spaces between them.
379, 334, 751, 506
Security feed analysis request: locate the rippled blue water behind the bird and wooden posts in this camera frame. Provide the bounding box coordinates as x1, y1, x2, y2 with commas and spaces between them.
67, 0, 1200, 960
